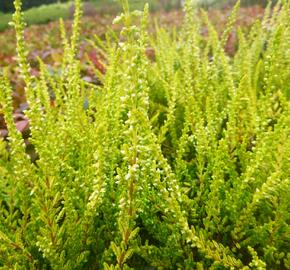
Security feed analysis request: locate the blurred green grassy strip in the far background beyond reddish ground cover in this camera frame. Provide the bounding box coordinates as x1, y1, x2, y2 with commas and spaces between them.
0, 0, 268, 31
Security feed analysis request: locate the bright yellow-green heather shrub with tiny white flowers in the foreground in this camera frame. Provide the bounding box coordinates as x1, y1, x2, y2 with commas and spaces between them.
0, 0, 290, 270
